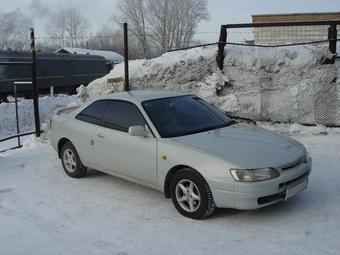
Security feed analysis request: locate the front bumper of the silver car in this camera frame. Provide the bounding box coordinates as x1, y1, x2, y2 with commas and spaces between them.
213, 159, 312, 210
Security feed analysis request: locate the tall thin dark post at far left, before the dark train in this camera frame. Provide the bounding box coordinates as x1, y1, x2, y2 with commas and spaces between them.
30, 28, 41, 137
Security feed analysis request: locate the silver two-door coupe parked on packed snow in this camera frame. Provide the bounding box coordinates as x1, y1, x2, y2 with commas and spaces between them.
51, 91, 312, 219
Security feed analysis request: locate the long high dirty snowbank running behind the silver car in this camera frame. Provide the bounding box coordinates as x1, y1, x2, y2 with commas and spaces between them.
75, 43, 340, 124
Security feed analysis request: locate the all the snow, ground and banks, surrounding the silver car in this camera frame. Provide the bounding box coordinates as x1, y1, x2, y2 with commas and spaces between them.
0, 43, 340, 255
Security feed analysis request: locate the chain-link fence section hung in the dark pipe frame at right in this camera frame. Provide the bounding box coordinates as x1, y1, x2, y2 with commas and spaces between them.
217, 21, 340, 126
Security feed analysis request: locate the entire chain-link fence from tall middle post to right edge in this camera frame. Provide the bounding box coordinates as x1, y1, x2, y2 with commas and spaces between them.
121, 21, 340, 126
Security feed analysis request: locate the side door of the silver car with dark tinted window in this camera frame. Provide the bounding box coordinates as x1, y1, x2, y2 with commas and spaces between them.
93, 100, 156, 186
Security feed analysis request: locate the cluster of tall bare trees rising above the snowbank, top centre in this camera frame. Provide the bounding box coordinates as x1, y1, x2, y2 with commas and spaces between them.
116, 0, 208, 57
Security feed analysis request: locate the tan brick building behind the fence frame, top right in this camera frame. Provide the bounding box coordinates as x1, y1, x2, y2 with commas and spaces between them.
252, 12, 340, 45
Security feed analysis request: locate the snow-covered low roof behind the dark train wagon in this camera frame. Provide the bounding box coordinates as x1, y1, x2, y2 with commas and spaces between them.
56, 47, 124, 63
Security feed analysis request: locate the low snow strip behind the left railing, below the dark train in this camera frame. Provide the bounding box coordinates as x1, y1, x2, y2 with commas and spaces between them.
0, 95, 76, 138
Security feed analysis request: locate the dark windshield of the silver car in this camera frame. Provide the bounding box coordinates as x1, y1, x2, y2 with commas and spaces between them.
142, 96, 234, 138
